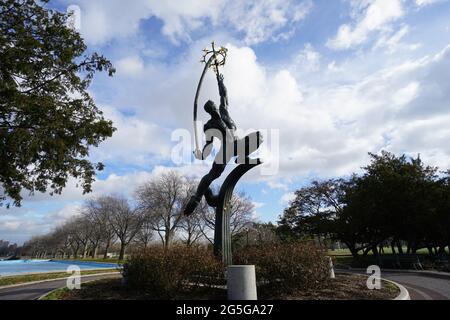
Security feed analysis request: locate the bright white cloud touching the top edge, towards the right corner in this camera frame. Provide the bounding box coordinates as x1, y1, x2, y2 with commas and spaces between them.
327, 0, 404, 50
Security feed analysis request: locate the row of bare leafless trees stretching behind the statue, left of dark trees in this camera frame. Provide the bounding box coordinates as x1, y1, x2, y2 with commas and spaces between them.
22, 172, 254, 260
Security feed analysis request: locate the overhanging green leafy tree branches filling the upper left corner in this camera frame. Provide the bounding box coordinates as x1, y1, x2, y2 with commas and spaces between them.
0, 0, 115, 206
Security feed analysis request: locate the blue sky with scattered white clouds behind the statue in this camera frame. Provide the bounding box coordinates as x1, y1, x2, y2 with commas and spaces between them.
0, 0, 450, 244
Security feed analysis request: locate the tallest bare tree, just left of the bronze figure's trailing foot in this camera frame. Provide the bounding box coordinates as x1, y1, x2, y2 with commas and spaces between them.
136, 171, 191, 249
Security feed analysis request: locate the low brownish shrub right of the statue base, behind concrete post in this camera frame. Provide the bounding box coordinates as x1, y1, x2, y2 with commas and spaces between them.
234, 243, 329, 294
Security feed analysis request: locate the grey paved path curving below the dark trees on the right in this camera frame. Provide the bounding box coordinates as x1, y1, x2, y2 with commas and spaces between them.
382, 272, 450, 300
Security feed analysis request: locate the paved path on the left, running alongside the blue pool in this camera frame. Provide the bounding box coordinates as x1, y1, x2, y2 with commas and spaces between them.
0, 274, 120, 300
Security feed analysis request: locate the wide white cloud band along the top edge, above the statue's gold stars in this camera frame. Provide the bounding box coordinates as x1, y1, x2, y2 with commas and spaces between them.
66, 0, 312, 44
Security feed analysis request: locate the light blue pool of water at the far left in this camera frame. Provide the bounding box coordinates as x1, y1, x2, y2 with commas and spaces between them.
0, 260, 118, 277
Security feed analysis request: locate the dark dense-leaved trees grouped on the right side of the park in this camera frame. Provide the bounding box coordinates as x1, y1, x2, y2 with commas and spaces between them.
277, 152, 450, 257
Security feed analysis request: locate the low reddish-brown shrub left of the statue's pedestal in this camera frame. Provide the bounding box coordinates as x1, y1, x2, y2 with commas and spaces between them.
122, 246, 224, 299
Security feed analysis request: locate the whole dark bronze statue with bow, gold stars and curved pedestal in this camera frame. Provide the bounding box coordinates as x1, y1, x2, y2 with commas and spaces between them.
184, 42, 263, 265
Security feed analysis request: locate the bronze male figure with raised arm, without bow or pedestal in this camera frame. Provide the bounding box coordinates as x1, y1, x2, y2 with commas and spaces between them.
184, 73, 263, 216
